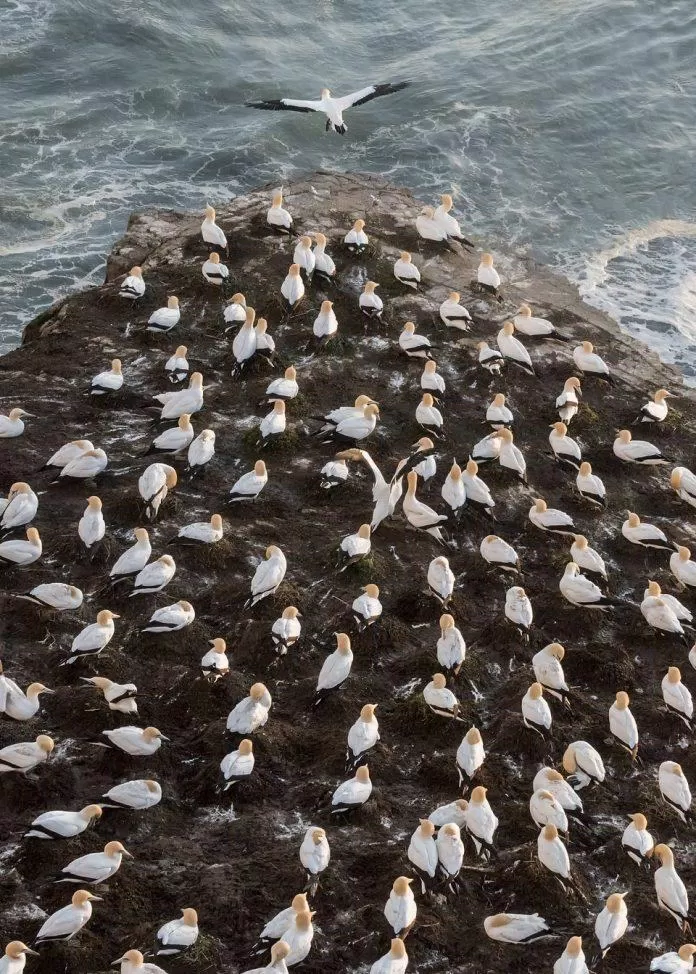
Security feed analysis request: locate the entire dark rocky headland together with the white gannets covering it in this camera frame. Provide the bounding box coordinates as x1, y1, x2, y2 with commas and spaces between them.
0, 176, 696, 974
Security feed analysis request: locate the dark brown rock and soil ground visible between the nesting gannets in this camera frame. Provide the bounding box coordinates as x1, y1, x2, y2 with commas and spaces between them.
0, 174, 696, 974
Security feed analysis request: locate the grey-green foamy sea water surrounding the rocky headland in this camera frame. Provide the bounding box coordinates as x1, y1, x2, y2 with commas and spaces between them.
0, 0, 696, 382
